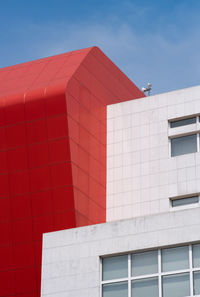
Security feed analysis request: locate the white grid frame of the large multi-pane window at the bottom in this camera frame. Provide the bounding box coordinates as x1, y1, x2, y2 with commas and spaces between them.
100, 242, 200, 297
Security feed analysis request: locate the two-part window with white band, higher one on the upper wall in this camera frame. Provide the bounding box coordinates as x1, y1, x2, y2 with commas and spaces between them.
169, 117, 200, 157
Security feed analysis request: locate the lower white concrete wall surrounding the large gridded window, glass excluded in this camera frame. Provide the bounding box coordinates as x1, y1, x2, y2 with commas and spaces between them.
41, 208, 200, 297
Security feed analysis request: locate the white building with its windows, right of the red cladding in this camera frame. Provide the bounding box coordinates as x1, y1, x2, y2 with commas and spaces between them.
41, 86, 200, 297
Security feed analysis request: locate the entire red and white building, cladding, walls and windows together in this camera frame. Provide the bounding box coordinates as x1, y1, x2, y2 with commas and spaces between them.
0, 47, 200, 297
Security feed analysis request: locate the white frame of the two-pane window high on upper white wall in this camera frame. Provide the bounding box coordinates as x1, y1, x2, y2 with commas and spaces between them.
168, 114, 200, 158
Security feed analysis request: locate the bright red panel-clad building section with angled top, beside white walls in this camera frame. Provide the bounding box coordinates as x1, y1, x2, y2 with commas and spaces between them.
0, 47, 144, 297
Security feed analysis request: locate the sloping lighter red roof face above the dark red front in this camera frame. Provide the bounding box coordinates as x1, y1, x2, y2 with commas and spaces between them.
0, 48, 92, 96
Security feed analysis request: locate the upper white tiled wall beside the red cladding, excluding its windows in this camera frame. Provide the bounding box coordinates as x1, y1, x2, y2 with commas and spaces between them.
107, 86, 200, 221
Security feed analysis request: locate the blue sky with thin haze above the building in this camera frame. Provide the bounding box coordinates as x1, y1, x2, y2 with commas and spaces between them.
0, 0, 200, 94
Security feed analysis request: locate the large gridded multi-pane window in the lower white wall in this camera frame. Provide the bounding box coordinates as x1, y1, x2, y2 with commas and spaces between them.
101, 243, 200, 297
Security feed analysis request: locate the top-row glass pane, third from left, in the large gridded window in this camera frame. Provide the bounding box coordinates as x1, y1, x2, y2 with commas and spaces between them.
162, 246, 189, 272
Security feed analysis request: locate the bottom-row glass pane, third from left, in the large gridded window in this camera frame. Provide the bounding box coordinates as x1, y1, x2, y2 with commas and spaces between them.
162, 273, 190, 297
